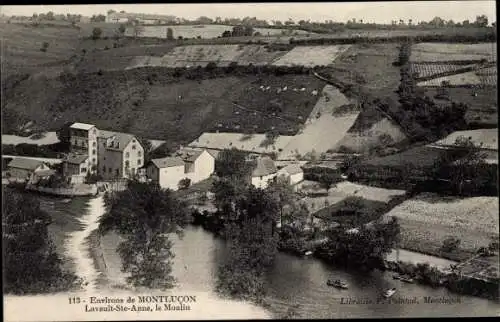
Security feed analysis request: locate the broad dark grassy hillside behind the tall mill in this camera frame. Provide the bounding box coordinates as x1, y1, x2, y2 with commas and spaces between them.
4, 69, 323, 148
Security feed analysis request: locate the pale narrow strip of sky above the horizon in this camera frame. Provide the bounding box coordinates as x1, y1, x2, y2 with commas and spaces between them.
0, 0, 496, 23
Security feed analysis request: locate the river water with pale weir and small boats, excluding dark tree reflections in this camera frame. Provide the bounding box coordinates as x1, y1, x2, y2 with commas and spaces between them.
35, 198, 500, 319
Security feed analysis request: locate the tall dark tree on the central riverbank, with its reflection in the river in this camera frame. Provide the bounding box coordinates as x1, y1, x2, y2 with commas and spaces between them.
217, 186, 278, 298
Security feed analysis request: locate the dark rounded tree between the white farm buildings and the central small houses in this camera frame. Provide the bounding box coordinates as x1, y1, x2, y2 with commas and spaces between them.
215, 148, 251, 180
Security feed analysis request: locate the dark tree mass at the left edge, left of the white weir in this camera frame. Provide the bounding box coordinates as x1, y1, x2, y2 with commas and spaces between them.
2, 189, 81, 294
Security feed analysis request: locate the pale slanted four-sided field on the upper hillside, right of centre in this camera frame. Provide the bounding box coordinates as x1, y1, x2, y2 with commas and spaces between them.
273, 45, 350, 67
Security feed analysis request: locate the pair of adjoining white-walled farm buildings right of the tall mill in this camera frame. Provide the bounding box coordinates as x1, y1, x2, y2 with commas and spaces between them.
146, 148, 215, 190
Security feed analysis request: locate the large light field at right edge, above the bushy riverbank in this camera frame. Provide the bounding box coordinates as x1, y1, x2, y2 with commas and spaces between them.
385, 193, 499, 254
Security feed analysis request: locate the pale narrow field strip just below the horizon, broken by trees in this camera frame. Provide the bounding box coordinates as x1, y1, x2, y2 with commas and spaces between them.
133, 25, 310, 38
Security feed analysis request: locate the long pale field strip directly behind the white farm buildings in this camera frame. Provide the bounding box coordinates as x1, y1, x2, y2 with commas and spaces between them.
189, 133, 293, 153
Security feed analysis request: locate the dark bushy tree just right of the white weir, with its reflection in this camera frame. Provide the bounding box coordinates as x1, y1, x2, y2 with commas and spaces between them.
99, 181, 190, 289
